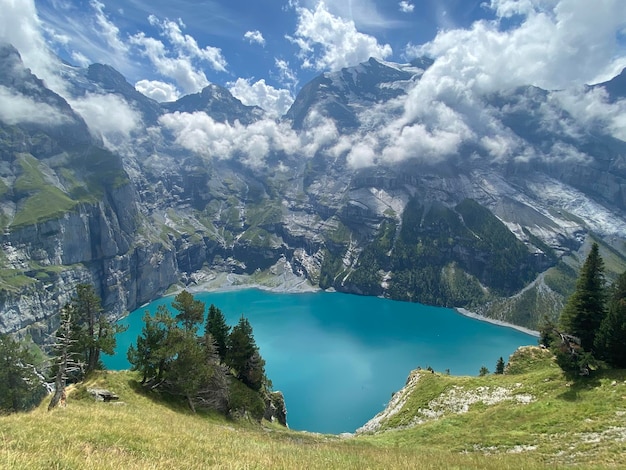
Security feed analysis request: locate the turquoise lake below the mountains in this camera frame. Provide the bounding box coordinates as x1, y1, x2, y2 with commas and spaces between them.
104, 289, 537, 433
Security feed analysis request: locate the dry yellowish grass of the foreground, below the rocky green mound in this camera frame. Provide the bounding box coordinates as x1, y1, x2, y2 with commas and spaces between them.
0, 366, 609, 470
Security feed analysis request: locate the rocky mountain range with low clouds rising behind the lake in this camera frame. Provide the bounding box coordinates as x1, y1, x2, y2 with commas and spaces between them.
0, 40, 626, 340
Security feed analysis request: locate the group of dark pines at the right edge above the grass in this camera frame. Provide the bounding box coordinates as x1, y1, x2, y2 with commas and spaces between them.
540, 243, 626, 374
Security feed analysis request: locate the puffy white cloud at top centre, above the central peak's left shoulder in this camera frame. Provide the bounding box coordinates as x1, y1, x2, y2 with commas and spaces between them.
288, 1, 392, 70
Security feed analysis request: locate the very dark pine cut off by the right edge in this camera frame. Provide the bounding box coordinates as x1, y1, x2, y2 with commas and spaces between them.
595, 272, 626, 368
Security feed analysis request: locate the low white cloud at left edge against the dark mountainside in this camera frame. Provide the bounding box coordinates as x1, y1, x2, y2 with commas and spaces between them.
0, 85, 69, 126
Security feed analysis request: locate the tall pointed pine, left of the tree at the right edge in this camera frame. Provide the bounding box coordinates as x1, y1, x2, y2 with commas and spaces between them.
559, 243, 605, 351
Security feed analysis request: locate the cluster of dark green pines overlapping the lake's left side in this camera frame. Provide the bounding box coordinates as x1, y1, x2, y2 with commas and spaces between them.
128, 291, 270, 419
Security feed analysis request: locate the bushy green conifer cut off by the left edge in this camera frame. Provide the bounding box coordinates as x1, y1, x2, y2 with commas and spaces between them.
0, 334, 45, 412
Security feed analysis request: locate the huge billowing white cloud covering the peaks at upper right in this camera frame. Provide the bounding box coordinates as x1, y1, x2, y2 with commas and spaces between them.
316, 0, 626, 172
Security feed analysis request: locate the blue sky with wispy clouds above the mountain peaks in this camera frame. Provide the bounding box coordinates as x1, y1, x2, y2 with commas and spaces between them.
35, 0, 494, 92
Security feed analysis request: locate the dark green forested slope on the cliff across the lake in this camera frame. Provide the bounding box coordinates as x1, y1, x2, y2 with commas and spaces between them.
338, 199, 538, 307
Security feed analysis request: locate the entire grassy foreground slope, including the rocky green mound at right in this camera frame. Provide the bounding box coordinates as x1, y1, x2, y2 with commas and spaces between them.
0, 348, 626, 470
